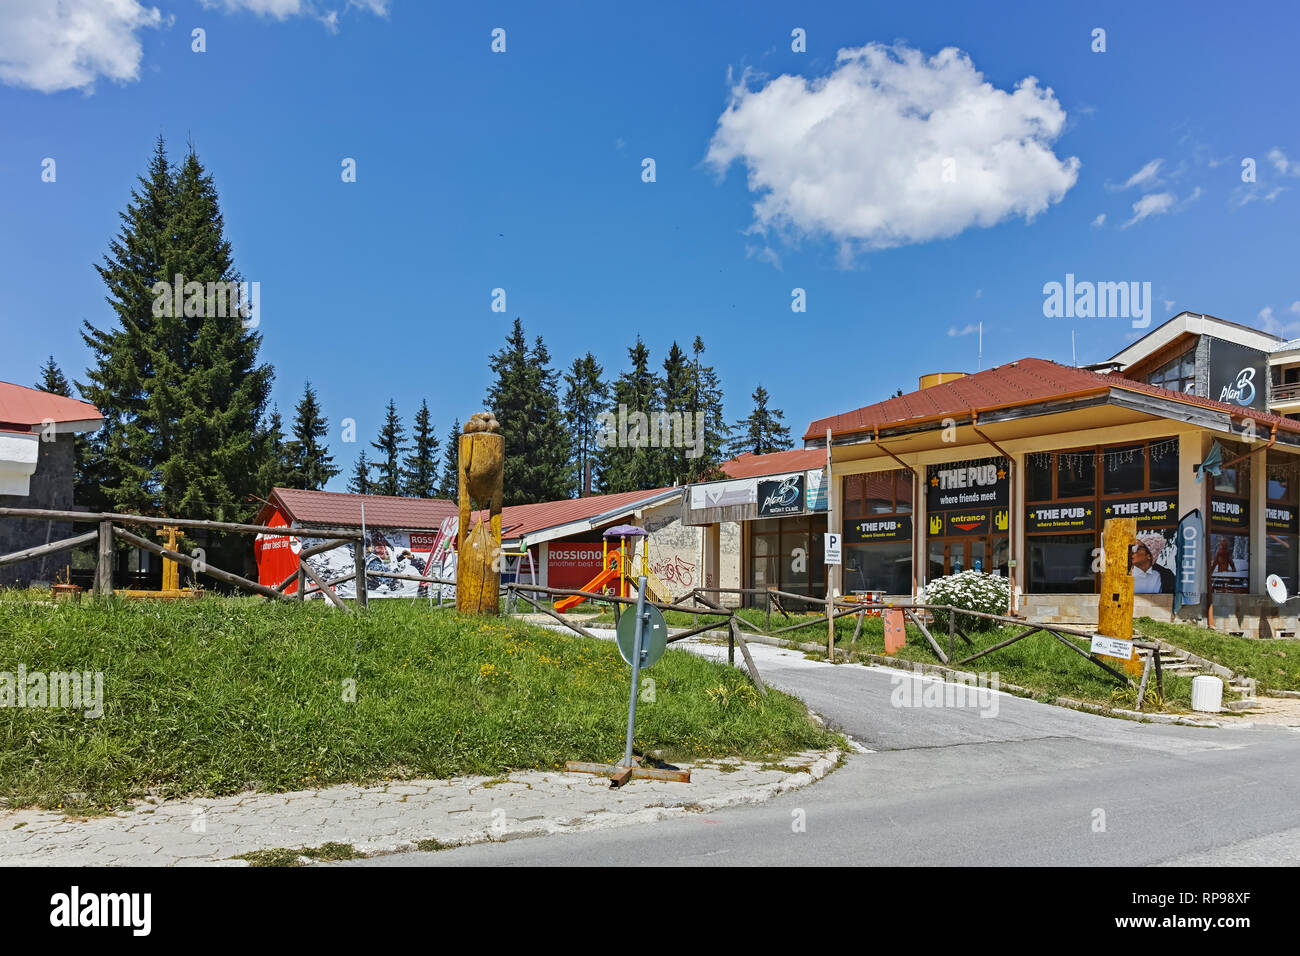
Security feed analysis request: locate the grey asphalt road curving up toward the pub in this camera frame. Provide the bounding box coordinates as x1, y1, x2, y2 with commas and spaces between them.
345, 646, 1300, 866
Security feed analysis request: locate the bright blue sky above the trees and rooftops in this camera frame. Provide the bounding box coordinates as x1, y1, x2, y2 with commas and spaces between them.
0, 0, 1300, 488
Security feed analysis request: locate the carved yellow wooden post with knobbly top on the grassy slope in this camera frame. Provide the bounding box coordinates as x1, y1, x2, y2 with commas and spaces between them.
456, 411, 506, 614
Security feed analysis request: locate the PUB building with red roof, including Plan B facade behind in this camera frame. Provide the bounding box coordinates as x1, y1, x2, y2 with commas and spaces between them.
803, 313, 1300, 635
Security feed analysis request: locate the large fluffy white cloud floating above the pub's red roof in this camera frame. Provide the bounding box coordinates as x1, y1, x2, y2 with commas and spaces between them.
706, 44, 1079, 256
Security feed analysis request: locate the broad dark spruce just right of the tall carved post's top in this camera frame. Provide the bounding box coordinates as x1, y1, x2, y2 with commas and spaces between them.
485, 319, 576, 505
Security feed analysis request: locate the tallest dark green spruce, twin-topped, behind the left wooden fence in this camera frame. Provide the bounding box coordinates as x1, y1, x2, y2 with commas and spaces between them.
78, 139, 273, 567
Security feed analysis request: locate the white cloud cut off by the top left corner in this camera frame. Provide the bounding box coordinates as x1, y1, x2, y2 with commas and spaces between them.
0, 0, 163, 92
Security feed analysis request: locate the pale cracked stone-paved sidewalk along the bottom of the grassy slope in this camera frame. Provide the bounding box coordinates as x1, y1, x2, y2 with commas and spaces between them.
0, 750, 839, 866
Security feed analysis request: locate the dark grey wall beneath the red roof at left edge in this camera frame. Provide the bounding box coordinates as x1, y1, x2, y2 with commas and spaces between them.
0, 434, 74, 588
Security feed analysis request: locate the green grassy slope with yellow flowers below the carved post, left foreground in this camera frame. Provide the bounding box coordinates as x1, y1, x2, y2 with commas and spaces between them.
0, 594, 840, 812
